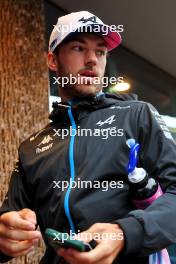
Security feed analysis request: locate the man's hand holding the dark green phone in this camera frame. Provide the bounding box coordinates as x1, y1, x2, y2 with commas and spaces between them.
58, 223, 124, 264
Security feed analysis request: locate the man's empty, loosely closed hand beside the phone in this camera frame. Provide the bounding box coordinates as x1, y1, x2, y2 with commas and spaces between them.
0, 209, 41, 257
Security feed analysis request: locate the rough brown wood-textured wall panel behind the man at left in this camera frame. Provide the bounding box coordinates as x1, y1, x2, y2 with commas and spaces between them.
0, 0, 48, 264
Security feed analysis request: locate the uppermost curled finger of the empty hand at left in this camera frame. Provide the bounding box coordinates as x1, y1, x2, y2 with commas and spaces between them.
0, 212, 35, 230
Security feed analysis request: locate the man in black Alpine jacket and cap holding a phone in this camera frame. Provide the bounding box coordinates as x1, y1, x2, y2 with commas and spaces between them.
0, 11, 176, 264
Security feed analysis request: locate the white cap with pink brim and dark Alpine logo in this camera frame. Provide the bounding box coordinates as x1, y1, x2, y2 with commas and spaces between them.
49, 11, 121, 52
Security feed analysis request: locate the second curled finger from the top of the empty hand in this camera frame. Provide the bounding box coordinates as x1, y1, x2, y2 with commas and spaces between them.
0, 224, 41, 240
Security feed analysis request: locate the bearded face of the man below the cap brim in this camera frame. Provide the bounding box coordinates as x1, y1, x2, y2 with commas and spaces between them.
55, 33, 107, 100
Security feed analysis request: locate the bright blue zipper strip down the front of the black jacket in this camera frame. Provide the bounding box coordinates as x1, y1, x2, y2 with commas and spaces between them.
64, 107, 76, 234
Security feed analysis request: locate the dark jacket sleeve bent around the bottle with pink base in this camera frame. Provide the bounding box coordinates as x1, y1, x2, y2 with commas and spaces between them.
116, 103, 176, 255
